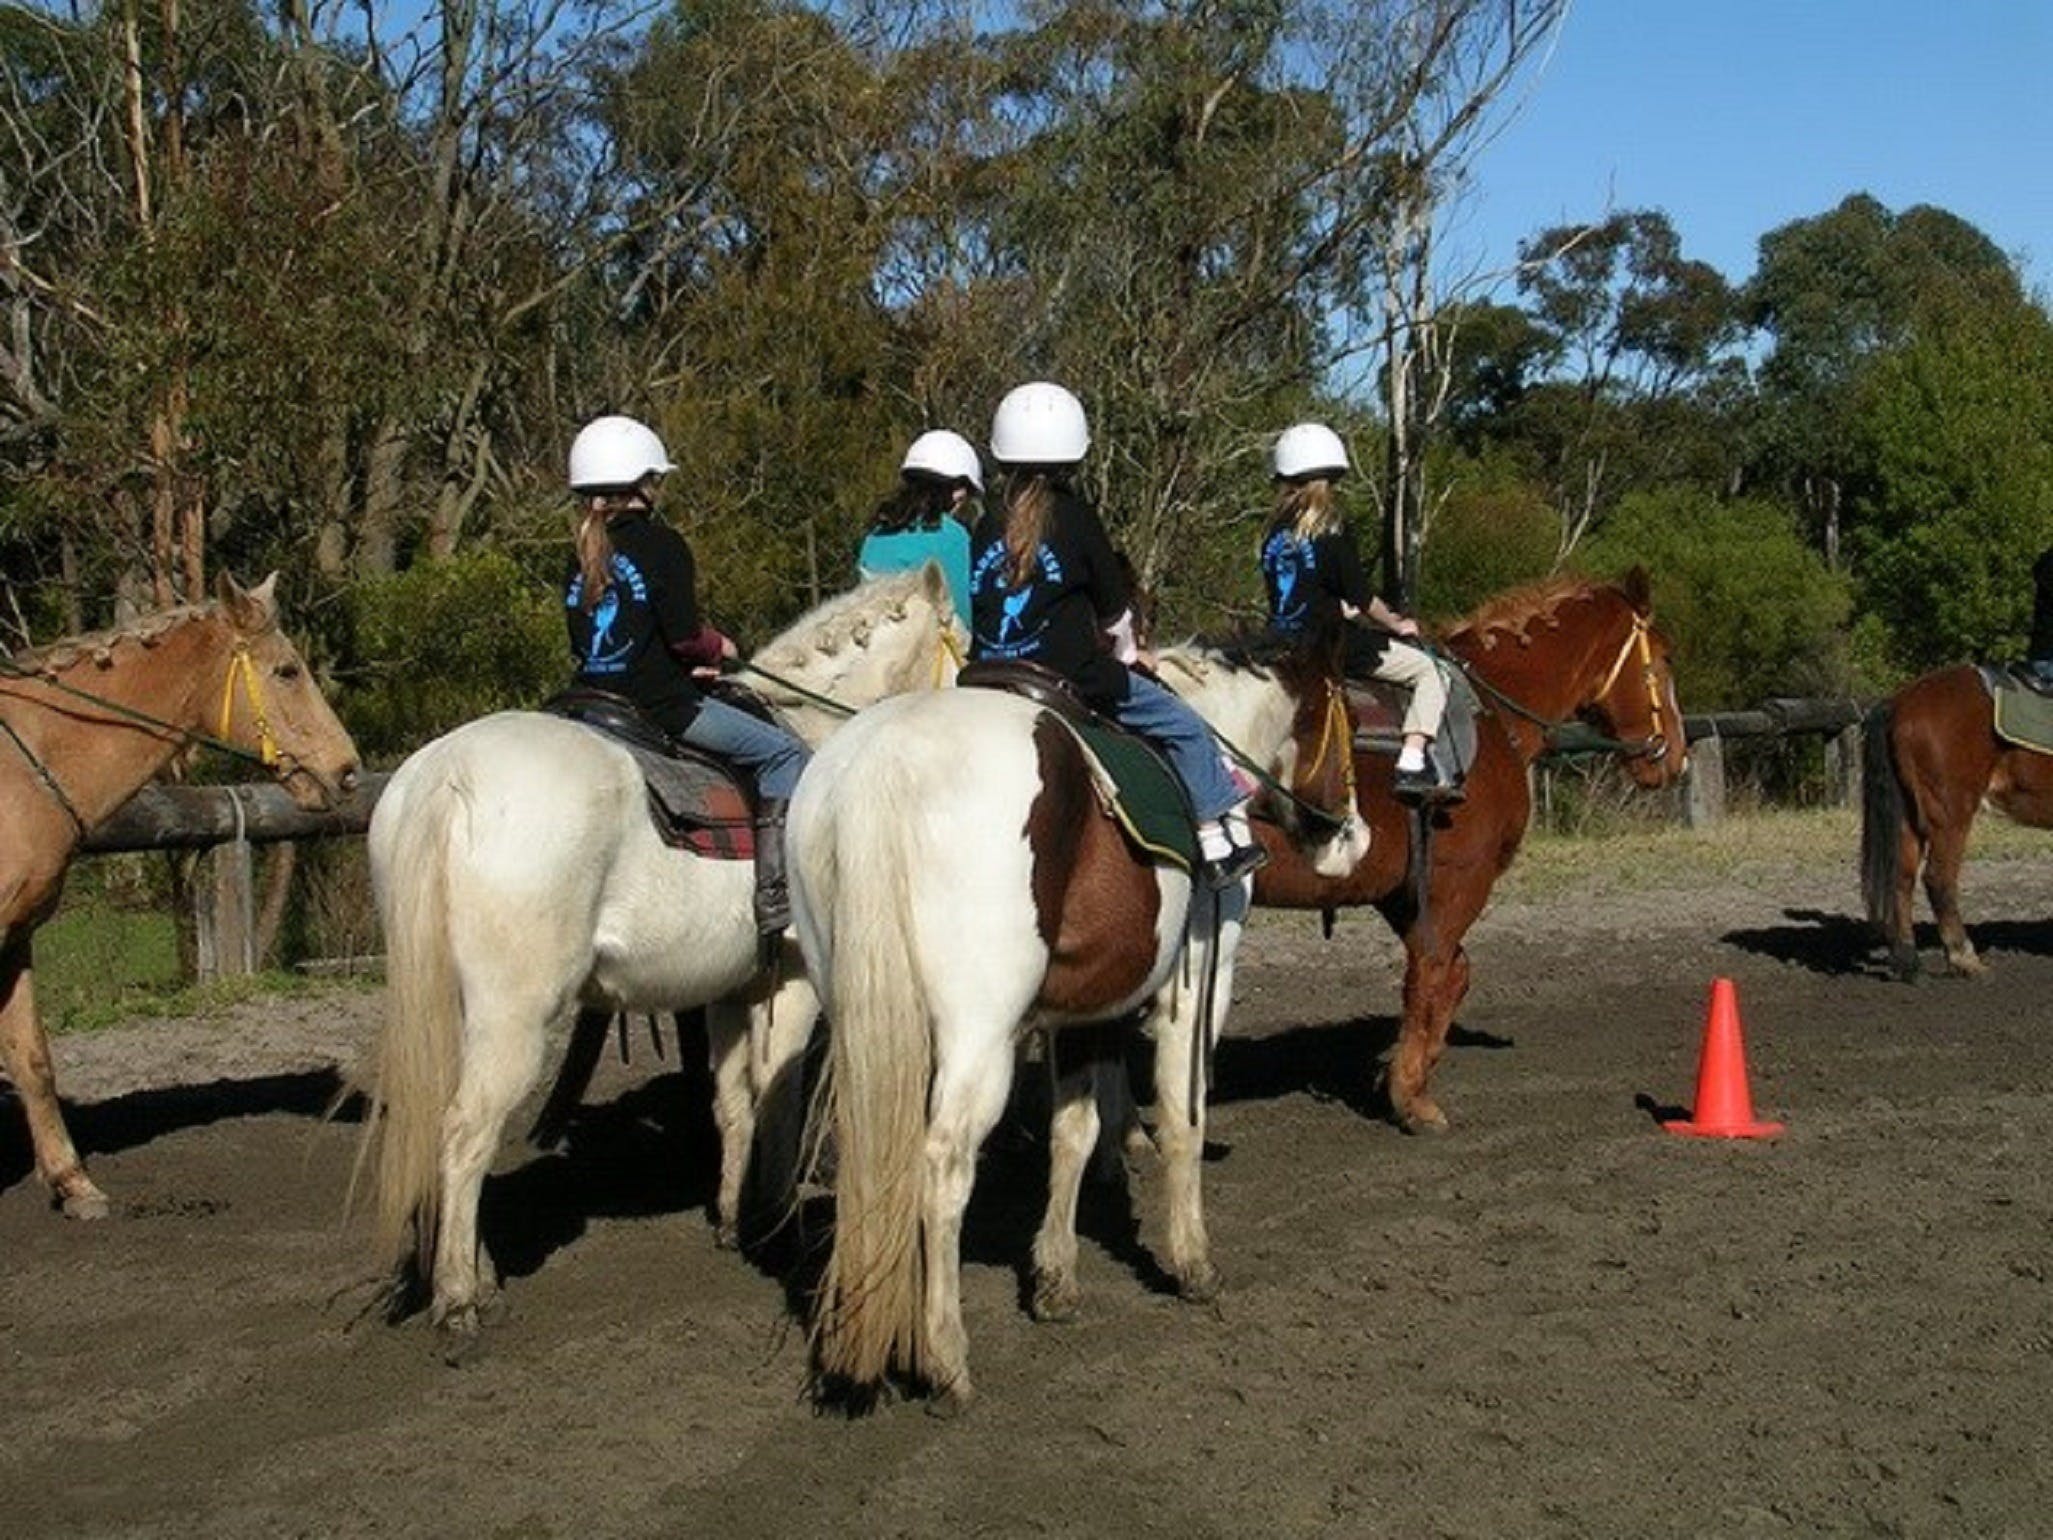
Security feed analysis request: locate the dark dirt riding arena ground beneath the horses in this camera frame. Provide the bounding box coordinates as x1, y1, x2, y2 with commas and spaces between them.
0, 837, 2053, 1540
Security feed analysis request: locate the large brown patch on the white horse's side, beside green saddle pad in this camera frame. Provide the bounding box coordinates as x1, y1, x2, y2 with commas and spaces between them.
1027, 717, 1162, 1014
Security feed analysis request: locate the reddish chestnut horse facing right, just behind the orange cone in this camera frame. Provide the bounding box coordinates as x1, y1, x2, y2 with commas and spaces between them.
1254, 569, 1686, 1131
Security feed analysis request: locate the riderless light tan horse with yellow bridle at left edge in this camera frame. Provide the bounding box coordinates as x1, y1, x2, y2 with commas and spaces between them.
0, 573, 357, 1220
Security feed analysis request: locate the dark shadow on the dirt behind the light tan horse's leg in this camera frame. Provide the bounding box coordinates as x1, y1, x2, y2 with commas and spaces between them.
0, 1066, 361, 1215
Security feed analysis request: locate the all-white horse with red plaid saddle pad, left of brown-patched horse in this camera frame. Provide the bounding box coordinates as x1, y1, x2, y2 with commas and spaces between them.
359, 567, 961, 1337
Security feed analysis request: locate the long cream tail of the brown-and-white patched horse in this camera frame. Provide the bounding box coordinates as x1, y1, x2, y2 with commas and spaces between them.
792, 747, 934, 1398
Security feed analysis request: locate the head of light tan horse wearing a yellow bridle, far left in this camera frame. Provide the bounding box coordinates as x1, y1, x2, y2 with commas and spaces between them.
214, 573, 363, 811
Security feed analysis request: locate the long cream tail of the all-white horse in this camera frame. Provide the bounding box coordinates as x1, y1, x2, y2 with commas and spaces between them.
349, 767, 462, 1283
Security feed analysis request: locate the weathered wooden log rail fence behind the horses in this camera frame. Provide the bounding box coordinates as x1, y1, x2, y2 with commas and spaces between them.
84, 700, 1862, 979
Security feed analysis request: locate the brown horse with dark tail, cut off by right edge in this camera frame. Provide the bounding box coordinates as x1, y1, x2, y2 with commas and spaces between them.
1860, 663, 2053, 979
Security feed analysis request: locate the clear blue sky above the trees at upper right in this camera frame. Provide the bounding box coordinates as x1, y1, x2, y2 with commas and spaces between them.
1441, 0, 2053, 298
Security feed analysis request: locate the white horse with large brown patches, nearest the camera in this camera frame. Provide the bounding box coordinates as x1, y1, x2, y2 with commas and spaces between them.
786, 649, 1367, 1411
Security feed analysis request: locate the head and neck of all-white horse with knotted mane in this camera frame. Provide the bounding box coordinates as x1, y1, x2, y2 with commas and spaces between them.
749, 563, 969, 745
